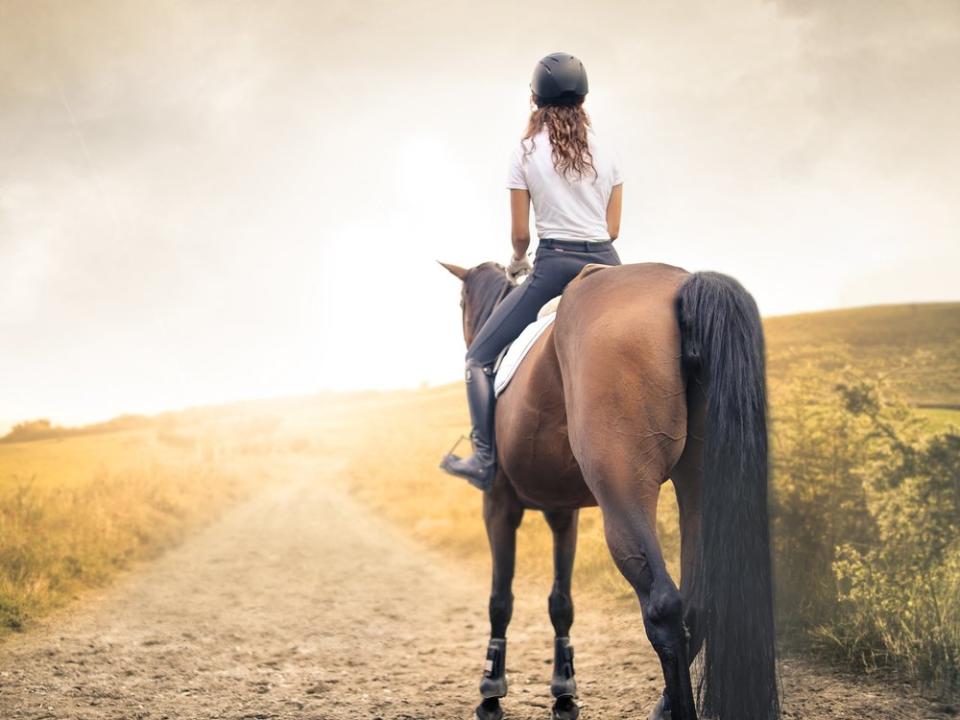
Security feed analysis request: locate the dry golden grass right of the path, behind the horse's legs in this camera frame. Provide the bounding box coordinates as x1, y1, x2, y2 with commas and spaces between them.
346, 384, 679, 603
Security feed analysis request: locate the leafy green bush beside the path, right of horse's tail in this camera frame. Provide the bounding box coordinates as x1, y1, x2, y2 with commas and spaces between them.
773, 370, 960, 689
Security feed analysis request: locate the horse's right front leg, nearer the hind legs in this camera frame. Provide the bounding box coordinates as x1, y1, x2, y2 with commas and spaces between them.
543, 510, 580, 720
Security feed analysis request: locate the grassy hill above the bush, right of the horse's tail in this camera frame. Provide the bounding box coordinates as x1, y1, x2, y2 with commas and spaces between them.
764, 303, 960, 406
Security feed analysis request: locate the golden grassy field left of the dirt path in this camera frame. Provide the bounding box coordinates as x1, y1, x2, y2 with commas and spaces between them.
0, 396, 368, 635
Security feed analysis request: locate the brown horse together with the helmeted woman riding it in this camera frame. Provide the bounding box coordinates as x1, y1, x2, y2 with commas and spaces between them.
443, 50, 780, 720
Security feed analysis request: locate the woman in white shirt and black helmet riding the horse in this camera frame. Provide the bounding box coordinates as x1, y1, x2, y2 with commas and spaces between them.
440, 53, 623, 490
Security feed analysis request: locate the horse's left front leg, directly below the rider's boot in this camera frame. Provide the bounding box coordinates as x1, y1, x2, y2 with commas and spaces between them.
476, 474, 523, 720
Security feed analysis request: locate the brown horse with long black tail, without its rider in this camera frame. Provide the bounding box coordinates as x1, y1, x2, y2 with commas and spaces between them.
444, 263, 780, 720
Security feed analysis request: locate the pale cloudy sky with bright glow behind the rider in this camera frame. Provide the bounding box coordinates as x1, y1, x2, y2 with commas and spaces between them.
0, 0, 960, 426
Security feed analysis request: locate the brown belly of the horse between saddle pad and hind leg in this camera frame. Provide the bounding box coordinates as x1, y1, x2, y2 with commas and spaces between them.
496, 327, 597, 509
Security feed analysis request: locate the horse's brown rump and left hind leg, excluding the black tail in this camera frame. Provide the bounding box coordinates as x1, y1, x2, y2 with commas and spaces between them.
556, 265, 696, 720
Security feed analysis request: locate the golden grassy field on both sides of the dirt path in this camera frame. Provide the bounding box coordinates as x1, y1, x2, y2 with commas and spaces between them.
0, 304, 960, 688
